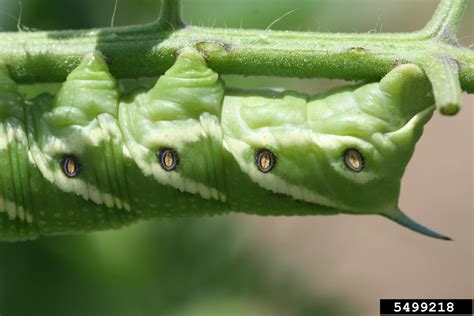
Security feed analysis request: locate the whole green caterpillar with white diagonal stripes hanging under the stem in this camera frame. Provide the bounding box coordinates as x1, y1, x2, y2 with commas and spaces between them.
0, 48, 448, 240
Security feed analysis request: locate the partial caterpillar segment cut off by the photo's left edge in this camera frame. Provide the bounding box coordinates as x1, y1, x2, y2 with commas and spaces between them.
0, 65, 38, 240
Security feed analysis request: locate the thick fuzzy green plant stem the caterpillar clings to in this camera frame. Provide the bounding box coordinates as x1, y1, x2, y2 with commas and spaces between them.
0, 0, 474, 113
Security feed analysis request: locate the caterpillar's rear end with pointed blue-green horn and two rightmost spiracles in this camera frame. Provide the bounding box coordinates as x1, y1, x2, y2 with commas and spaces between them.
225, 65, 446, 238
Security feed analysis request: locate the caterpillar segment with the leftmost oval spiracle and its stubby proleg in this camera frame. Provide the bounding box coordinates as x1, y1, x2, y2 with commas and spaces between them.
27, 53, 135, 234
